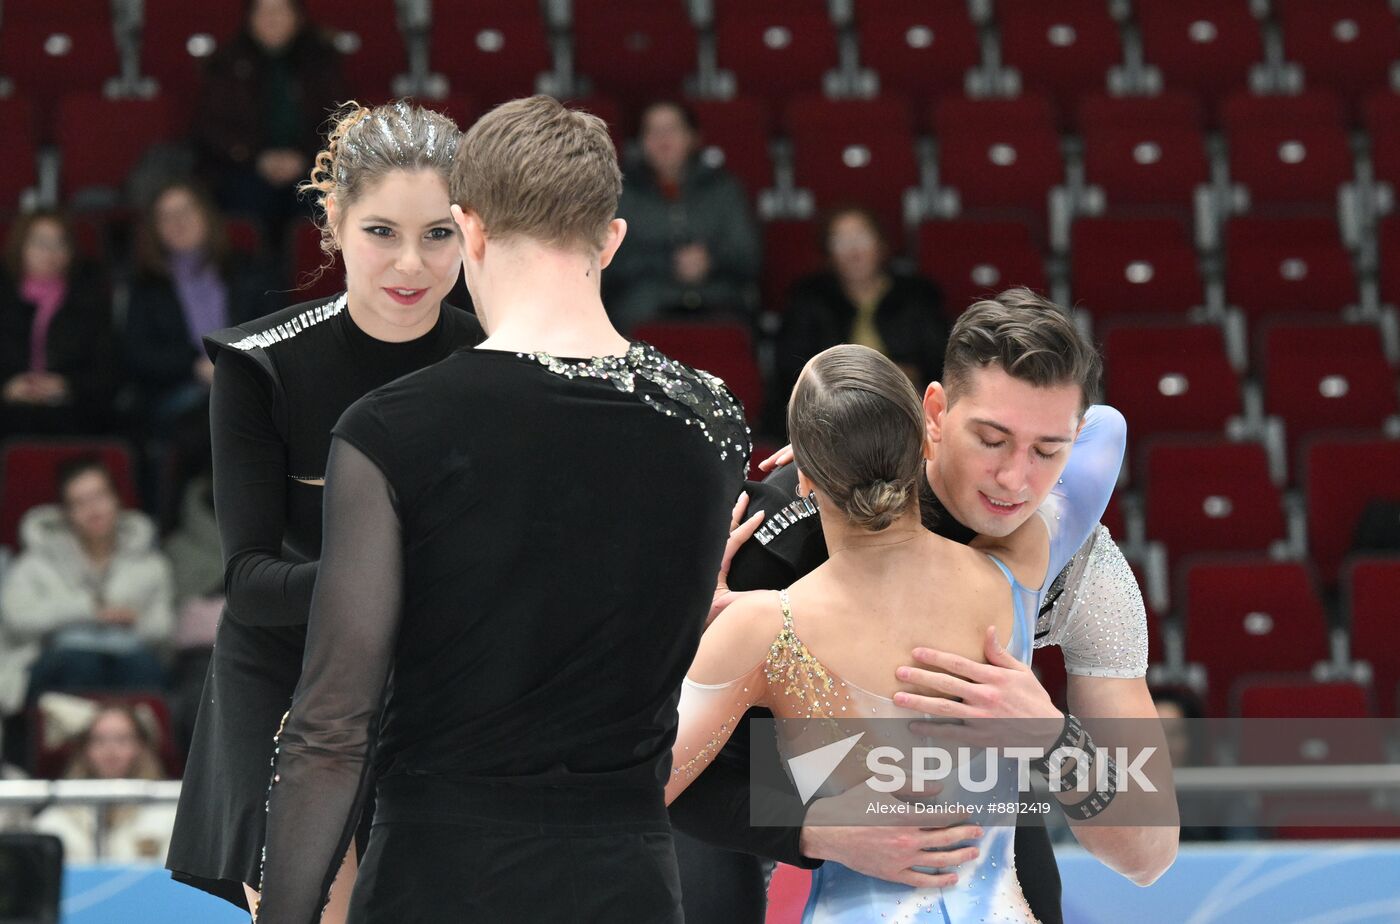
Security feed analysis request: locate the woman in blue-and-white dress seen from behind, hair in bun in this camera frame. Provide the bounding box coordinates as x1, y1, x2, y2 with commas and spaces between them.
666, 344, 1044, 924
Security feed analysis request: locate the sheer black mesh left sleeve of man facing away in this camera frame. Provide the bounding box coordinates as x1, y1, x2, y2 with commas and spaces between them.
258, 437, 403, 924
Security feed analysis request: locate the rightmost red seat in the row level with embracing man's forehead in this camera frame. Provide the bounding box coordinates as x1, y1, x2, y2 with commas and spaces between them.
1261, 323, 1400, 459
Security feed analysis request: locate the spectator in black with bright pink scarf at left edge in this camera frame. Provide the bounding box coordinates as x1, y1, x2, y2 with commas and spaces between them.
0, 210, 119, 435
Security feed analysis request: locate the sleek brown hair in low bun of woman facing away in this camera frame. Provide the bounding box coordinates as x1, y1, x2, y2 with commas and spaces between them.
788, 343, 924, 532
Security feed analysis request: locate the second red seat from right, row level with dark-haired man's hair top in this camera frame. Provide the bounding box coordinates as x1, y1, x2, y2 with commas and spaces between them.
1225, 217, 1357, 316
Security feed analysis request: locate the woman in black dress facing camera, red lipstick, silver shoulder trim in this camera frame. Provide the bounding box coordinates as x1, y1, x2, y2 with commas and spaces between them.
167, 102, 482, 924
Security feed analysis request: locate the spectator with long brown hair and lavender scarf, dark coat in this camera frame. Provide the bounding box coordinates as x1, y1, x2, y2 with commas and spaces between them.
126, 179, 276, 435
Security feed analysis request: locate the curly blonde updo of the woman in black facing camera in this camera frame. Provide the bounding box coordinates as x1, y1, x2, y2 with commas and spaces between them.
297, 99, 462, 255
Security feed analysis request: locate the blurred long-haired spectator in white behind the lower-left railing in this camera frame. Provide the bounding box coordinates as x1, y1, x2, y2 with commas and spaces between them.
34, 704, 175, 862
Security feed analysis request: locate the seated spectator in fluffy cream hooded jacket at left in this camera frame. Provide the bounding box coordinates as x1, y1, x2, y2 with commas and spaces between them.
0, 458, 174, 701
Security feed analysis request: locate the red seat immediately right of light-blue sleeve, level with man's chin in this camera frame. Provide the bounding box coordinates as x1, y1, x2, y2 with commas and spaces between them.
1144, 440, 1287, 560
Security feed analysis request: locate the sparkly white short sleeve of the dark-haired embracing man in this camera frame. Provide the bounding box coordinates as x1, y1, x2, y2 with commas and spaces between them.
1036, 525, 1148, 678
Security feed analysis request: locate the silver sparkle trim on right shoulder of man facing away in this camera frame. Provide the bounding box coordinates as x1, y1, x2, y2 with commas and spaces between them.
517, 342, 752, 472
